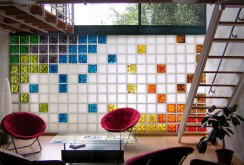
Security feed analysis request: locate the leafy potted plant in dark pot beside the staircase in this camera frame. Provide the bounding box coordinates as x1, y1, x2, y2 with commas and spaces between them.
197, 104, 244, 165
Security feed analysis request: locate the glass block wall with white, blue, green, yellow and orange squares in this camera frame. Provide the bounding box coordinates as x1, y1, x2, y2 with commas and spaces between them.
10, 35, 205, 134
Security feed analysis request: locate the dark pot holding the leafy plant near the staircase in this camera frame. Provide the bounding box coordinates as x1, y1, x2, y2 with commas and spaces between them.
215, 149, 234, 165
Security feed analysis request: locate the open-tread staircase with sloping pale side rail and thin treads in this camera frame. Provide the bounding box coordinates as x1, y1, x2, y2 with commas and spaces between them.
178, 4, 244, 142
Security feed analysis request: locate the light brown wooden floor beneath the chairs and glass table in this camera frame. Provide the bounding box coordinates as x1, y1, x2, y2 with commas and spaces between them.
1, 136, 243, 165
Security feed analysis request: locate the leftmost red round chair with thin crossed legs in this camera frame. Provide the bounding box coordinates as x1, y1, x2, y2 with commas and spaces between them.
1, 112, 46, 155
